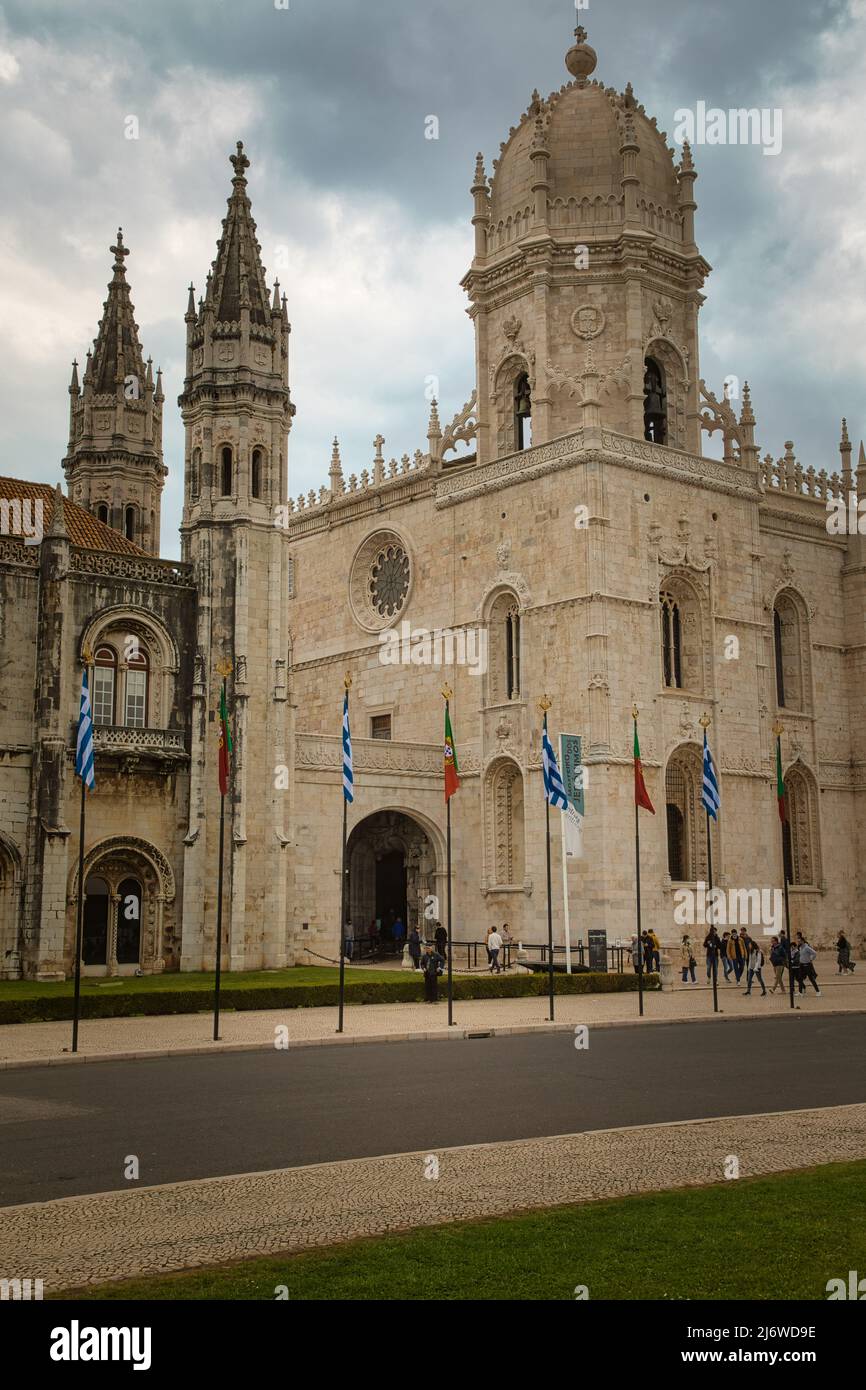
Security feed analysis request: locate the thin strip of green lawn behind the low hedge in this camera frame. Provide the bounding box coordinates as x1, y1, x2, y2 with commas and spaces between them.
0, 965, 400, 999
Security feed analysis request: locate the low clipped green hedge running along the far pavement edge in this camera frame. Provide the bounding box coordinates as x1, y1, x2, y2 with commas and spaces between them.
0, 974, 657, 1024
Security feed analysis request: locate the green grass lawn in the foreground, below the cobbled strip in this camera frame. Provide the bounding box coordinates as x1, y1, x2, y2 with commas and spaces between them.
53, 1162, 866, 1301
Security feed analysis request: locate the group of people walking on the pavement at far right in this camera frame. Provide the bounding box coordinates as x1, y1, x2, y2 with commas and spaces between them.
680, 927, 855, 998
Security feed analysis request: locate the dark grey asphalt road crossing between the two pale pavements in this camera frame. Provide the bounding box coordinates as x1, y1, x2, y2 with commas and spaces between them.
0, 1015, 866, 1205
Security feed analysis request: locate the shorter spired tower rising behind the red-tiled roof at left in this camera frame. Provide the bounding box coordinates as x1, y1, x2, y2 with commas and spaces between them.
63, 228, 168, 555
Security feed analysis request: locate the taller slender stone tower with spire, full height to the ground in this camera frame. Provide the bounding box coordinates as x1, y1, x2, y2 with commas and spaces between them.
178, 143, 295, 970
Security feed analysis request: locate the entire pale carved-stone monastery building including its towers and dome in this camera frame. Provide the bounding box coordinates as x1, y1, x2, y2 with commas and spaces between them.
0, 29, 866, 974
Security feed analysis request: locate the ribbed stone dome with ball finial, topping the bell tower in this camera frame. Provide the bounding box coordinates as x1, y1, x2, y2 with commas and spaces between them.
489, 26, 691, 252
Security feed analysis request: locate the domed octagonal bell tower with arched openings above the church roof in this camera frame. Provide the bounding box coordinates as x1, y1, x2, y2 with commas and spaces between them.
463, 26, 710, 463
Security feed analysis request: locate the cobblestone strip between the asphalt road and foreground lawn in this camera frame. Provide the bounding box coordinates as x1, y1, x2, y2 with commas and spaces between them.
0, 1104, 866, 1291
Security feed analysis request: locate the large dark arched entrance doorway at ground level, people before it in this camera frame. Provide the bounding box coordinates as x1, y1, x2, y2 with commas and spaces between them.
346, 810, 438, 944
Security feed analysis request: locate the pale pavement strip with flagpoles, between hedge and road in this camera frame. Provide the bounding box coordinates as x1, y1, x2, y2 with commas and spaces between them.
0, 956, 866, 1068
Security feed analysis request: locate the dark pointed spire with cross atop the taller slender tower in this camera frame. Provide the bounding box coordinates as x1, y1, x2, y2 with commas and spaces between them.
206, 140, 270, 325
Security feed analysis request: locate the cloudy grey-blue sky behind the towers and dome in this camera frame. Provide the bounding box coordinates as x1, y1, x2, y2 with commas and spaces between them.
0, 0, 866, 556
